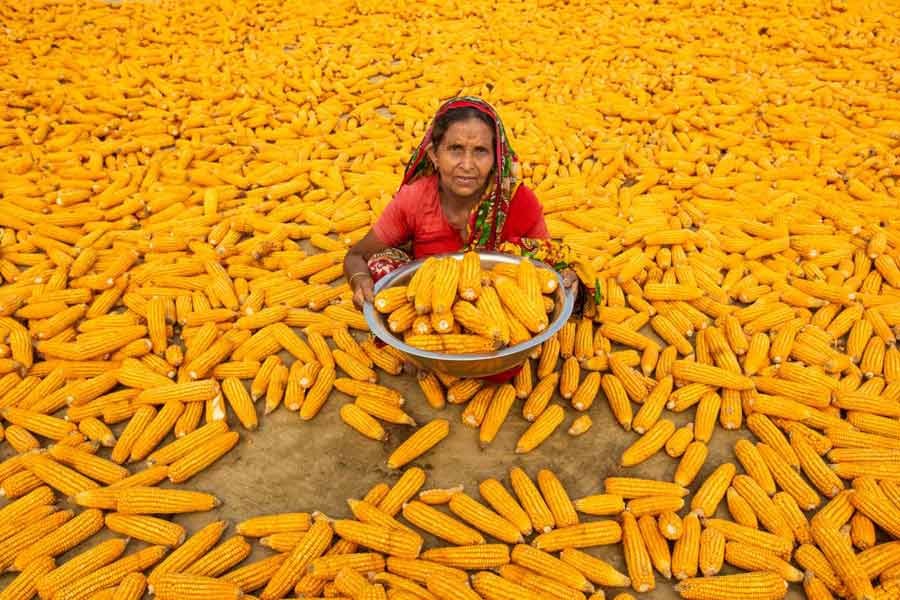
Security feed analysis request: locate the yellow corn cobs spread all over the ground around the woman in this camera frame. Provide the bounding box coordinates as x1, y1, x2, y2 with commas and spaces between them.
0, 0, 900, 600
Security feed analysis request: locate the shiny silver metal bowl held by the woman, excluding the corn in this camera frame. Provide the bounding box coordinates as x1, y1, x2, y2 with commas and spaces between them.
363, 252, 575, 377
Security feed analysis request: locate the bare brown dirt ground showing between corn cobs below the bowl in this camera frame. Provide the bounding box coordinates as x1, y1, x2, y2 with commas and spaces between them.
0, 356, 803, 600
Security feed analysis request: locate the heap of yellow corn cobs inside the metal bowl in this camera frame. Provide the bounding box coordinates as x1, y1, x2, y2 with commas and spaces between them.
374, 251, 558, 354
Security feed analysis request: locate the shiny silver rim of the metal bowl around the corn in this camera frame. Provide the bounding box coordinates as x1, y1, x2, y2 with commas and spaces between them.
363, 251, 575, 362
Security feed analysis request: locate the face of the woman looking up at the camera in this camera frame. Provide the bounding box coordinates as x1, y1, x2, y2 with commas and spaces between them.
428, 119, 494, 198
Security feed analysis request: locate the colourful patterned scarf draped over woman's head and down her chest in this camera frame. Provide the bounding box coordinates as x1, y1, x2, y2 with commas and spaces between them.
401, 96, 519, 250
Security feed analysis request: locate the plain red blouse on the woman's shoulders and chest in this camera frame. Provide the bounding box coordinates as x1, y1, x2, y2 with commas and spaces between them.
372, 175, 550, 258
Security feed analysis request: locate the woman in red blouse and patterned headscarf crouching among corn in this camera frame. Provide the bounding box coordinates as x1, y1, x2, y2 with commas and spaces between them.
344, 97, 577, 308
